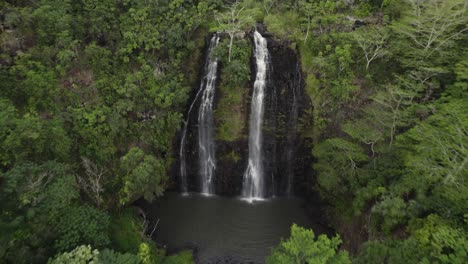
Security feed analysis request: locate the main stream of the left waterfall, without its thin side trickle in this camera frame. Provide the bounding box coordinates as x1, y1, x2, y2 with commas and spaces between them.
198, 35, 219, 195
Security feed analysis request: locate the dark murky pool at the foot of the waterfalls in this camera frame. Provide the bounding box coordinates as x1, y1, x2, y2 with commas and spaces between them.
140, 193, 327, 264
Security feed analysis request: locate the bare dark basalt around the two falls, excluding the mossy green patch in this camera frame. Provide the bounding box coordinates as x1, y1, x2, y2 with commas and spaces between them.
171, 28, 311, 196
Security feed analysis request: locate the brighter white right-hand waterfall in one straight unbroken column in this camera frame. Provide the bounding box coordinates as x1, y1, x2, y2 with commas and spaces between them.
242, 31, 269, 201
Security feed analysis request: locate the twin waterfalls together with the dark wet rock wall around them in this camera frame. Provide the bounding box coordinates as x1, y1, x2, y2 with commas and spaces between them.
179, 30, 300, 202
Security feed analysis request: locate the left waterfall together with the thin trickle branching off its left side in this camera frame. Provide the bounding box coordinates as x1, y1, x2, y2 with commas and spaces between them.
179, 34, 219, 194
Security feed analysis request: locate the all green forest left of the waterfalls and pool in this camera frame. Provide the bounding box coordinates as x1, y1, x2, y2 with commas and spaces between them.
0, 0, 217, 263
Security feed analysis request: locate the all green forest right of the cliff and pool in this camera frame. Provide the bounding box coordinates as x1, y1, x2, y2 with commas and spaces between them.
265, 0, 468, 263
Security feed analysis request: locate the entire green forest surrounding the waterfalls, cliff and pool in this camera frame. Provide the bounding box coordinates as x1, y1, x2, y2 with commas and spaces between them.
0, 0, 468, 263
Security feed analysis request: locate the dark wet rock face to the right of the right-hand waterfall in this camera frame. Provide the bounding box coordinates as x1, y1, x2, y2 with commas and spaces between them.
264, 38, 306, 195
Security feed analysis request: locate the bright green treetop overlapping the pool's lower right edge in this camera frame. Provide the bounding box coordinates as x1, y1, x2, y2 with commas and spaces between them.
267, 224, 351, 264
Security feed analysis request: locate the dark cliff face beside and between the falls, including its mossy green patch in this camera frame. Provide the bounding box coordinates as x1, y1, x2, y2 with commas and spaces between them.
176, 29, 310, 196
